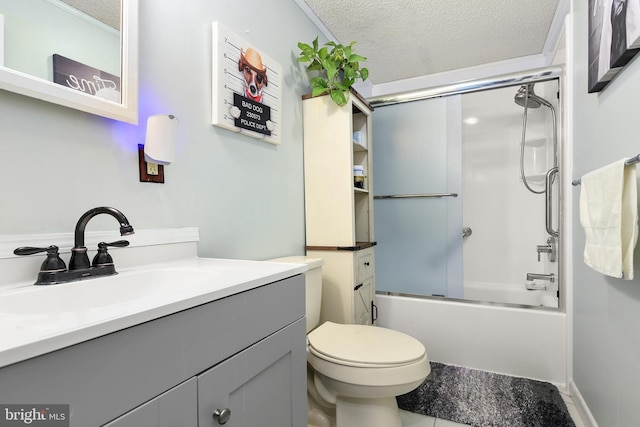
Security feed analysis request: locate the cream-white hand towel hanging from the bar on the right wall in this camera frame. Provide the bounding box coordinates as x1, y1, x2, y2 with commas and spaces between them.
580, 159, 638, 280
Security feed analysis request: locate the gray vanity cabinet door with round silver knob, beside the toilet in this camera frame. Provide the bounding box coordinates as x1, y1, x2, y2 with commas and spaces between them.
198, 318, 307, 427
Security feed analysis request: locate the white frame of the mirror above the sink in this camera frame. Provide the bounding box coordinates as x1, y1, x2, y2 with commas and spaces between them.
0, 0, 138, 124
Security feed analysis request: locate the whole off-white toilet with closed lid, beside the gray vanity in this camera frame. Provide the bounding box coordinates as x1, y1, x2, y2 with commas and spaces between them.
271, 256, 431, 427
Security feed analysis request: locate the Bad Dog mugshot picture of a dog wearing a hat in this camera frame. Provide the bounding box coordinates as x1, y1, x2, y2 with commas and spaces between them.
211, 22, 282, 144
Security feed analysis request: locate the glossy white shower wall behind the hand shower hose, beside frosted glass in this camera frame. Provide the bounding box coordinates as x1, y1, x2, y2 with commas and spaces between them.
462, 81, 558, 294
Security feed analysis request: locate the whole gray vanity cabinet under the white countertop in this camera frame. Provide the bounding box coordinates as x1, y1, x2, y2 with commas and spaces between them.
0, 275, 307, 427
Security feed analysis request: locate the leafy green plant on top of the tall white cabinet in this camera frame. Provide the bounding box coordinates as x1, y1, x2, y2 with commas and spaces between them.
298, 37, 369, 105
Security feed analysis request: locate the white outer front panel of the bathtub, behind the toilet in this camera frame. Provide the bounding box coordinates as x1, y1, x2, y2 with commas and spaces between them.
376, 293, 567, 386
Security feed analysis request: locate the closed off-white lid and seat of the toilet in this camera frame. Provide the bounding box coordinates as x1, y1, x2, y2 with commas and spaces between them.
307, 322, 425, 366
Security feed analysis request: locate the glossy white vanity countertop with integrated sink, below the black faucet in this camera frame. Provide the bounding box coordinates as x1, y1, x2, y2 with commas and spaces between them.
0, 258, 307, 367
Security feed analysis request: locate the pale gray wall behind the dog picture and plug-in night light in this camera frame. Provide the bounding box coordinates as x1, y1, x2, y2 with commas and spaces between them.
0, 0, 318, 259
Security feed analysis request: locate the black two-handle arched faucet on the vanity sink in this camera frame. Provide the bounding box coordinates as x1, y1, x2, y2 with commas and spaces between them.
13, 207, 134, 285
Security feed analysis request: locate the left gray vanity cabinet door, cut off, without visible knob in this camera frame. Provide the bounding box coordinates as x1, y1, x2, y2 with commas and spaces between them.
104, 378, 198, 427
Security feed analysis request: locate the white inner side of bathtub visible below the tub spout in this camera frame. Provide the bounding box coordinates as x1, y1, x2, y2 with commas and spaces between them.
464, 281, 558, 308
